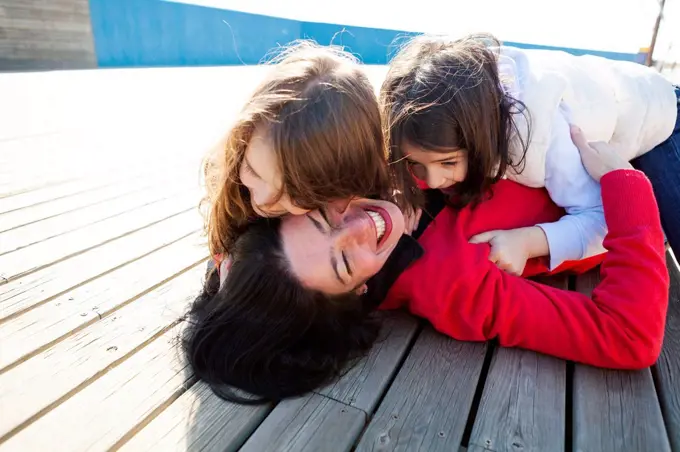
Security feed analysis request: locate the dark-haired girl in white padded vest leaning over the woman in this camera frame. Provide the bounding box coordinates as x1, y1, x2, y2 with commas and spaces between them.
381, 35, 680, 274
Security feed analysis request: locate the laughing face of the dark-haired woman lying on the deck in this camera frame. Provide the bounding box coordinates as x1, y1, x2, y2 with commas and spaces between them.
280, 199, 404, 294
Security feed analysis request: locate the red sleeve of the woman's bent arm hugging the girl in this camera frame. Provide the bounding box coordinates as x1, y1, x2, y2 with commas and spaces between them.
390, 170, 669, 369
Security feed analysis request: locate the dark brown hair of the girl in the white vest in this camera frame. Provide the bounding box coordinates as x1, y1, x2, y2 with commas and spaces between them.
380, 35, 529, 207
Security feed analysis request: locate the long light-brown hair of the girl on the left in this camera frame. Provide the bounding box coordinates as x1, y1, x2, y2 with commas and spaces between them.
203, 41, 392, 255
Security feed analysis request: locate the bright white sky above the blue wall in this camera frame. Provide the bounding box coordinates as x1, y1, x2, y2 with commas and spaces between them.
180, 0, 680, 79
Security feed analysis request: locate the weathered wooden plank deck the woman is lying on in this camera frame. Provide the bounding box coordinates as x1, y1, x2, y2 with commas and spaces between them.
0, 68, 680, 452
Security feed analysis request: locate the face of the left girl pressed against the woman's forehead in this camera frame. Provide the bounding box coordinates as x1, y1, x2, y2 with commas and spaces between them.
240, 127, 308, 217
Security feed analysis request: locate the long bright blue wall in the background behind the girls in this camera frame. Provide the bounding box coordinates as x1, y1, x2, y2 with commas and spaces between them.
90, 0, 644, 67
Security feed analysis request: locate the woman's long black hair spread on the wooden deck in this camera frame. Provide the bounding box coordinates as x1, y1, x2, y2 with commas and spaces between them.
182, 218, 379, 404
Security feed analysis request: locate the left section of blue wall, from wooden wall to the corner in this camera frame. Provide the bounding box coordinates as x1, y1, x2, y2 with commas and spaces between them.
90, 0, 300, 67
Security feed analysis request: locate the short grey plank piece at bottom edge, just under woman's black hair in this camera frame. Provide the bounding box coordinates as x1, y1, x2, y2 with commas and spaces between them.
241, 394, 366, 452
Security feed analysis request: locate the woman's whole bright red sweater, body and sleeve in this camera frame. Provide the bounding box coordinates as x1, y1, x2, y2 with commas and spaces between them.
381, 170, 669, 369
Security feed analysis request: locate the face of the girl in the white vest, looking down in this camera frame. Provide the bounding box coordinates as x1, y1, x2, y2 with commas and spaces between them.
403, 143, 468, 190
